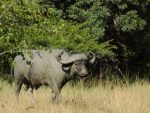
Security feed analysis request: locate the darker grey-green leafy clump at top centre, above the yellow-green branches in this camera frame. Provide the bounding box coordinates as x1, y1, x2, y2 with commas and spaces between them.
68, 0, 109, 39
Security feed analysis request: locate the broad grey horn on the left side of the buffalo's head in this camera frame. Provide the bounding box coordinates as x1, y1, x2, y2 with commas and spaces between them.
59, 54, 88, 64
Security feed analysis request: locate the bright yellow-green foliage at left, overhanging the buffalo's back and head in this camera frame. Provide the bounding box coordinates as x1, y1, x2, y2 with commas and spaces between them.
0, 0, 113, 56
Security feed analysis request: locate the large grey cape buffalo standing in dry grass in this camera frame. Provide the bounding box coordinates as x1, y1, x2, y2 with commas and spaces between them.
14, 49, 95, 100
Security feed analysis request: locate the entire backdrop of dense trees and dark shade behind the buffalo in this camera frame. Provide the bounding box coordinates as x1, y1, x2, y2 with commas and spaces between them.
0, 0, 150, 77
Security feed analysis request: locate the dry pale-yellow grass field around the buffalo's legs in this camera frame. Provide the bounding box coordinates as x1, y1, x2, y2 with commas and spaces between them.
0, 79, 150, 113
